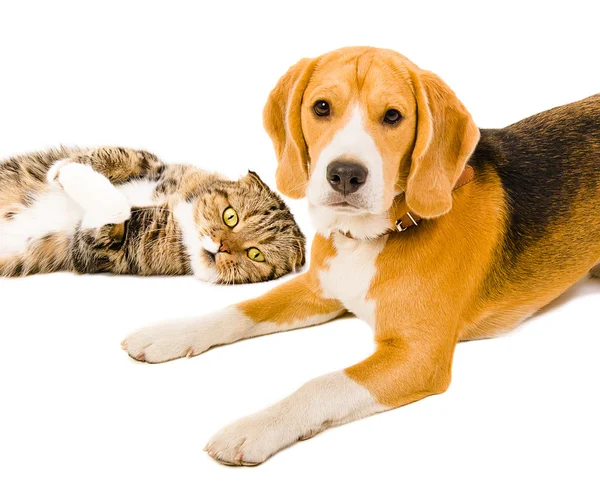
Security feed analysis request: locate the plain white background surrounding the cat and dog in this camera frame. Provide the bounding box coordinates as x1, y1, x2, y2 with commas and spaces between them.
0, 0, 600, 486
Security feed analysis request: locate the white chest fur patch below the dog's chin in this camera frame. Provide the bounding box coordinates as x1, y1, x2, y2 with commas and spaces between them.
319, 234, 387, 326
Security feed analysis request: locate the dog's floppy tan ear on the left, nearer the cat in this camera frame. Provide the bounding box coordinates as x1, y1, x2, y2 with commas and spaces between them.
263, 59, 314, 199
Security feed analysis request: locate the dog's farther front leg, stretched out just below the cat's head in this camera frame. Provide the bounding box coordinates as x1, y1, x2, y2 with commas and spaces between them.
122, 274, 344, 363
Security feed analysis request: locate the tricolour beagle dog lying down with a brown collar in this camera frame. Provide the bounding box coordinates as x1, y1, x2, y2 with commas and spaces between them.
123, 47, 600, 465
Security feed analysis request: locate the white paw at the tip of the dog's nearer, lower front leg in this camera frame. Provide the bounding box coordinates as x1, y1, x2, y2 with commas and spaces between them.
204, 409, 292, 466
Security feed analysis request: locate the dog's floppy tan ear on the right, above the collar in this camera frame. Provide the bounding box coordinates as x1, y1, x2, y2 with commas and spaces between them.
406, 67, 479, 218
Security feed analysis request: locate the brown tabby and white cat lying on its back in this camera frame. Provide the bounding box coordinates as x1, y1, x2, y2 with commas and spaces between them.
0, 147, 305, 284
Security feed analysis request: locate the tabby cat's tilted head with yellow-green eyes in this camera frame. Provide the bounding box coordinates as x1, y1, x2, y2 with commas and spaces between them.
194, 172, 306, 284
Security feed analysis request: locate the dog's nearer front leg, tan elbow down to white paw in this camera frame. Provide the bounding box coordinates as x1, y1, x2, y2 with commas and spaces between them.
206, 321, 455, 465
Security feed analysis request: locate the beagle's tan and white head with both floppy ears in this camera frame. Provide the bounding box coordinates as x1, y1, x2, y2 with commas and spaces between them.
264, 47, 479, 236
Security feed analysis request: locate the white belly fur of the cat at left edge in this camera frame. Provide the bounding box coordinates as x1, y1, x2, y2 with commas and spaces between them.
0, 188, 83, 256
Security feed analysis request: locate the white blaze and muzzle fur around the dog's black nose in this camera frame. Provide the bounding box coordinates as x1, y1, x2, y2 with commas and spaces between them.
307, 105, 383, 214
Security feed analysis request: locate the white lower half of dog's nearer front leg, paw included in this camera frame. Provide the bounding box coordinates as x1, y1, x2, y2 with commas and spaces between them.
206, 371, 386, 464
